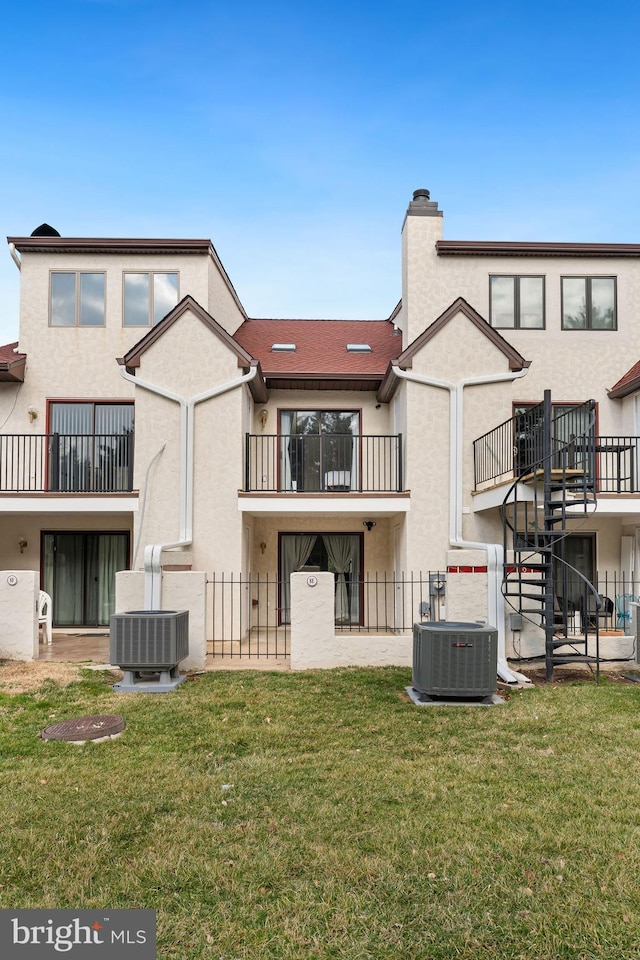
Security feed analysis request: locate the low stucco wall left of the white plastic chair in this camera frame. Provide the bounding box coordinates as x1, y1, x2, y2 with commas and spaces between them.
0, 570, 40, 660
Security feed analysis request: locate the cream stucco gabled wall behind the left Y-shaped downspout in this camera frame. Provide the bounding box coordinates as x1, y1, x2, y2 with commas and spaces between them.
129, 312, 248, 571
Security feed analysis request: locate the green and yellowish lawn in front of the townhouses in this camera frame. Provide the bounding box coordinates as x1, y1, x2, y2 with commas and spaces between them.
0, 667, 640, 960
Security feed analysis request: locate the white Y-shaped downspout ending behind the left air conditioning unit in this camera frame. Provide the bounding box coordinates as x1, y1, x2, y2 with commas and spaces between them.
120, 364, 258, 610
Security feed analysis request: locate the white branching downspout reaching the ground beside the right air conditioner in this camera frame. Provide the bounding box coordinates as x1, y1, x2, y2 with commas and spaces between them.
393, 364, 530, 683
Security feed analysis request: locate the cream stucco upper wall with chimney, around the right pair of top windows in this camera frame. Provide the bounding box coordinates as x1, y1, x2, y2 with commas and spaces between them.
407, 236, 640, 434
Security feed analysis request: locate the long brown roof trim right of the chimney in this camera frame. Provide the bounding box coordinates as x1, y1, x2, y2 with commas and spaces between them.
436, 240, 640, 257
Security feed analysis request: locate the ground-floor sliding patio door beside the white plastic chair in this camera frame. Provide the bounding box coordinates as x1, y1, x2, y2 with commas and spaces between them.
42, 532, 129, 627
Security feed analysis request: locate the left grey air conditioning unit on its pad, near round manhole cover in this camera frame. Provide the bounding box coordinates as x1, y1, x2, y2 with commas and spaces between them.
109, 610, 189, 693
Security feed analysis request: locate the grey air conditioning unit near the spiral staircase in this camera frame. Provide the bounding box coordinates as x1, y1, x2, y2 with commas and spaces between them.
413, 621, 498, 699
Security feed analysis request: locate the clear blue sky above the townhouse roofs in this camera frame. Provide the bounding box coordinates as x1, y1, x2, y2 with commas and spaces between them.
0, 0, 640, 343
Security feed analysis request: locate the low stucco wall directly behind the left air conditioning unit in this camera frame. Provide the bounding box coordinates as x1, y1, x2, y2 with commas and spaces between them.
116, 570, 207, 670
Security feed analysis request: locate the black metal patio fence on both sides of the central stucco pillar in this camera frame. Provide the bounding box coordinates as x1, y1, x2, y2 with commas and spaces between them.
207, 572, 438, 658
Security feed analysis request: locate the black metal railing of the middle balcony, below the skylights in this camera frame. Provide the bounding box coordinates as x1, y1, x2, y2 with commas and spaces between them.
245, 433, 404, 493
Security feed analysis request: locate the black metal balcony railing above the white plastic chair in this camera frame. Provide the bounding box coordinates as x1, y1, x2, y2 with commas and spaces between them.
0, 433, 133, 493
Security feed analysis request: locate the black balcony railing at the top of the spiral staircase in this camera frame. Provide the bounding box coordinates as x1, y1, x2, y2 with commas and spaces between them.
473, 415, 640, 493
